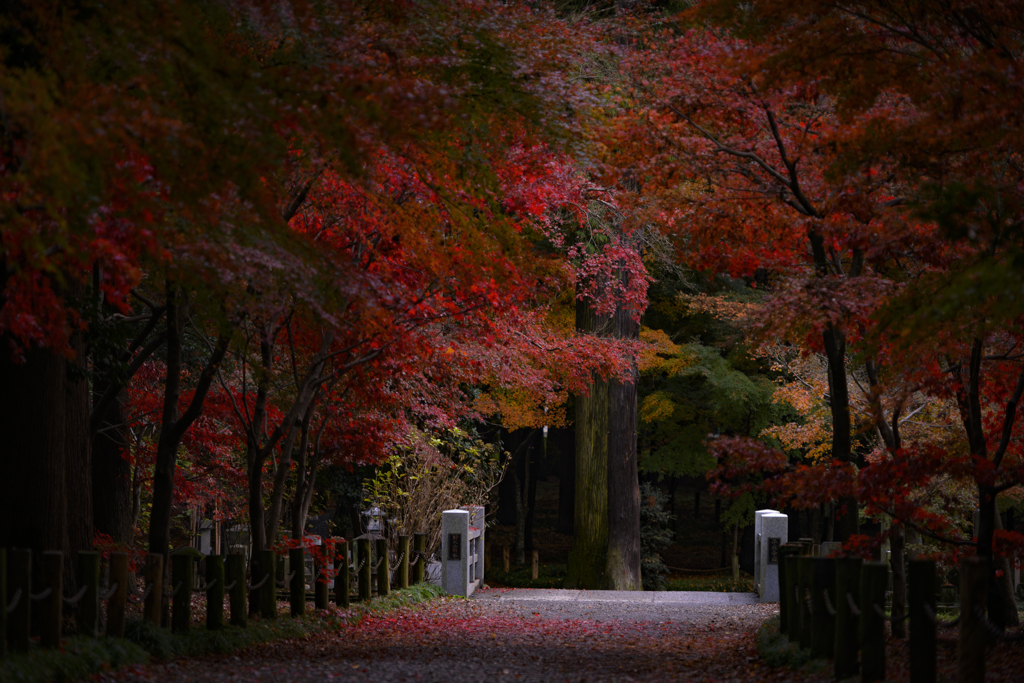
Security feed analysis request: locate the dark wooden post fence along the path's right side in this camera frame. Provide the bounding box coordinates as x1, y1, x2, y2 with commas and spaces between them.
778, 544, 1024, 683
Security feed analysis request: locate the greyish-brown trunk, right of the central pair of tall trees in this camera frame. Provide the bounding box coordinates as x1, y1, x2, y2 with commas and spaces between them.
605, 308, 642, 591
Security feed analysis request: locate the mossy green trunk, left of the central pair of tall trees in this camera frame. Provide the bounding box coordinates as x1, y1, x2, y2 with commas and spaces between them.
565, 301, 609, 590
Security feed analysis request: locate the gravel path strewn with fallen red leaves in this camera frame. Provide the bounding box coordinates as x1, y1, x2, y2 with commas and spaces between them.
108, 590, 815, 683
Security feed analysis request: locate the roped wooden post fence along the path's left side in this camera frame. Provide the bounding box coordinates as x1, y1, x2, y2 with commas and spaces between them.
0, 533, 426, 658
